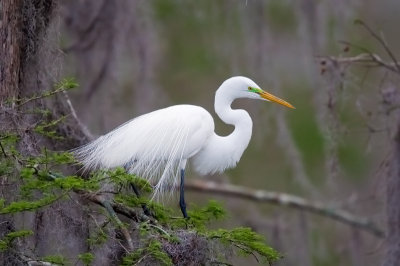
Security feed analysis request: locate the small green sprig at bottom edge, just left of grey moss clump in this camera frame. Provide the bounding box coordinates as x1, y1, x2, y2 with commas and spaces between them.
121, 240, 173, 266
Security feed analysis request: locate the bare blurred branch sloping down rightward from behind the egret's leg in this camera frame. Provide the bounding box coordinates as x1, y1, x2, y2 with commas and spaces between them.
185, 180, 384, 237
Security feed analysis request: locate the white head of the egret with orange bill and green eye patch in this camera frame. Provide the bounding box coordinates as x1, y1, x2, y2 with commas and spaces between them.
221, 76, 295, 109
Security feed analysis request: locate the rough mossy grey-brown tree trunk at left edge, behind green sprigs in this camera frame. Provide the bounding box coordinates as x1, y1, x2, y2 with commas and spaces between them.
0, 0, 88, 265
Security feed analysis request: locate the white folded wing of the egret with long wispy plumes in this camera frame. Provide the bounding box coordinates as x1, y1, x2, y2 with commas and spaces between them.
74, 107, 192, 195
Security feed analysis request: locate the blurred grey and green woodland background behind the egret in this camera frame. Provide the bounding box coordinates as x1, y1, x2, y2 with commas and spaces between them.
61, 0, 400, 266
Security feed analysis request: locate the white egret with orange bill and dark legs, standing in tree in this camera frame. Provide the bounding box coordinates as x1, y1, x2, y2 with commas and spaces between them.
74, 76, 294, 218
